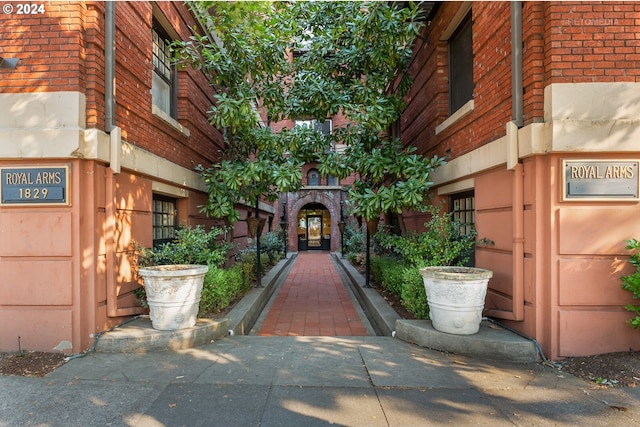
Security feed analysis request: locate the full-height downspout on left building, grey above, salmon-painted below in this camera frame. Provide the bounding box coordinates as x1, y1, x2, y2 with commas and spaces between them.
104, 1, 143, 317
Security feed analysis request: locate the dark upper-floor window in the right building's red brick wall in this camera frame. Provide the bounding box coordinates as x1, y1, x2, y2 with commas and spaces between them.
448, 13, 474, 114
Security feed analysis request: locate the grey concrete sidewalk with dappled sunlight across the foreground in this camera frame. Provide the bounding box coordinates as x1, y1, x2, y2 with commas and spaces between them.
0, 336, 640, 427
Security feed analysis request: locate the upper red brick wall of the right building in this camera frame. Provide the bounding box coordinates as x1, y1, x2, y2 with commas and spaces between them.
401, 2, 640, 158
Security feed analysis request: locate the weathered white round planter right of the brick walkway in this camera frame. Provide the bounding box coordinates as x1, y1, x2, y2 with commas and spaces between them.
420, 267, 493, 335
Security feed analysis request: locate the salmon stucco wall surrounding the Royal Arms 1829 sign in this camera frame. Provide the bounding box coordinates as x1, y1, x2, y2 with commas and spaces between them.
0, 161, 84, 351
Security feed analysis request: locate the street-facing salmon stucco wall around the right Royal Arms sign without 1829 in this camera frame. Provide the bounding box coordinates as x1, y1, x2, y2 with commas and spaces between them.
548, 154, 640, 357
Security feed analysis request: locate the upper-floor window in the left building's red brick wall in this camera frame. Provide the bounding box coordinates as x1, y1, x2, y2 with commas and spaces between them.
151, 20, 177, 119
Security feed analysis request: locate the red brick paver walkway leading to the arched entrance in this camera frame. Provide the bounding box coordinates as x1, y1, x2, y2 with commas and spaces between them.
257, 252, 367, 336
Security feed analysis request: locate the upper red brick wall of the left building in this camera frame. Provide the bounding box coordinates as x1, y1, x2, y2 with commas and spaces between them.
0, 1, 223, 169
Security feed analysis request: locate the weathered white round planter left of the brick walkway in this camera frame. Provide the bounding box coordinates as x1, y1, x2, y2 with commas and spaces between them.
138, 265, 209, 331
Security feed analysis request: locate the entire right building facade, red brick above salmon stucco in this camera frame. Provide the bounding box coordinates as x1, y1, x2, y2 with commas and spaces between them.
401, 2, 640, 359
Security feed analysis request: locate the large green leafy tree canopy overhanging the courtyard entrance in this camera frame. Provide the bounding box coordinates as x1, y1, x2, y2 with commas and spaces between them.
172, 1, 442, 222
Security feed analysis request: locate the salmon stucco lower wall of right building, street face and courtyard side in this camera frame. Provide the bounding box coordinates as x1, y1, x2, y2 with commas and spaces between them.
464, 154, 640, 360
